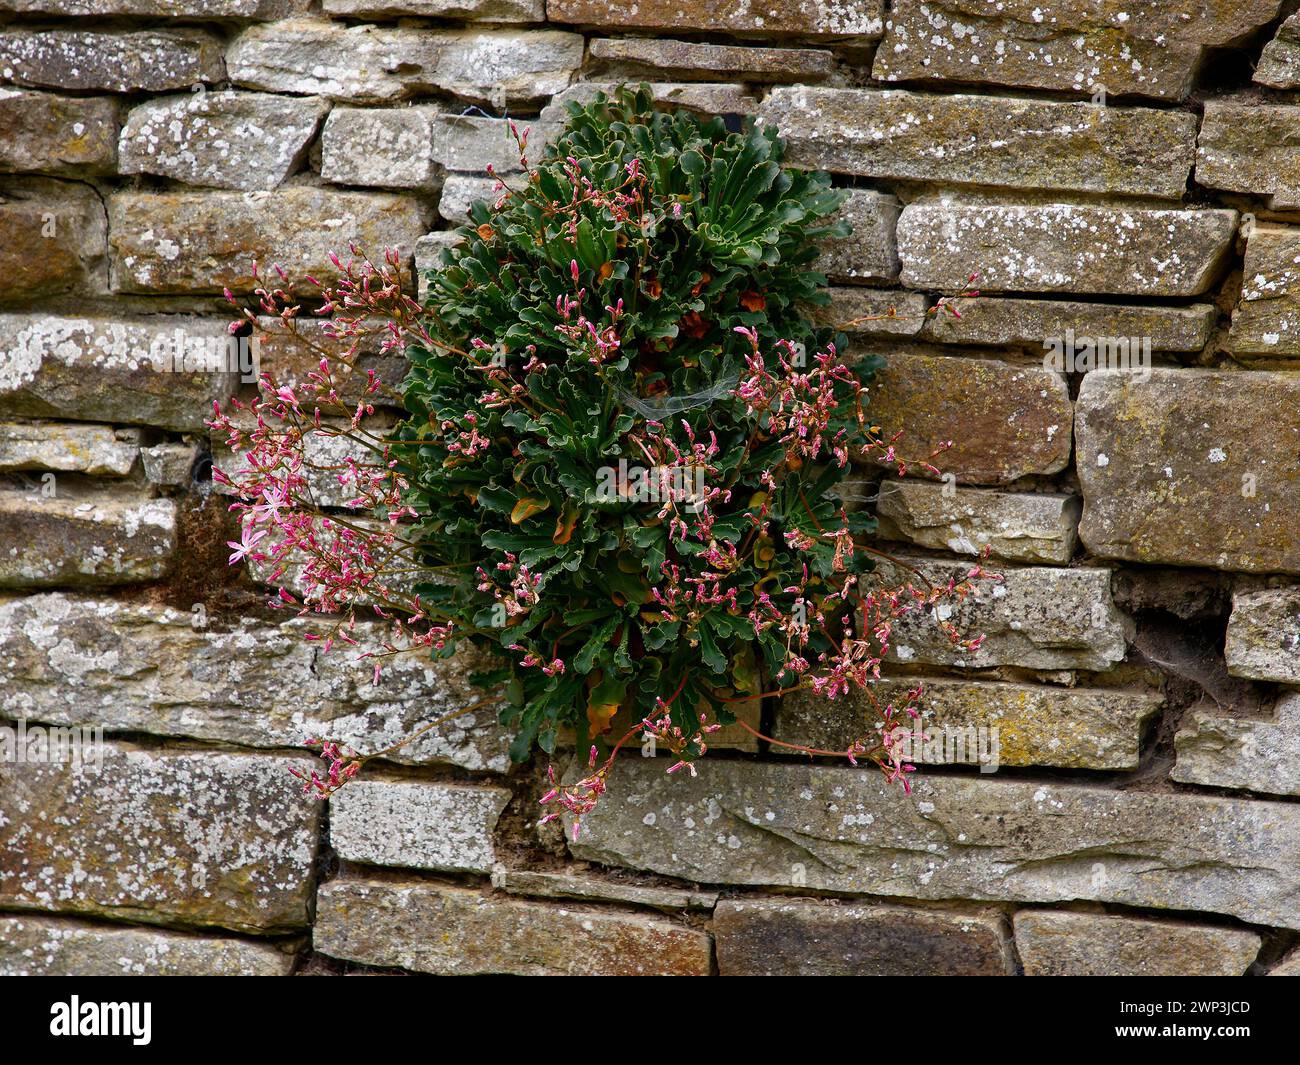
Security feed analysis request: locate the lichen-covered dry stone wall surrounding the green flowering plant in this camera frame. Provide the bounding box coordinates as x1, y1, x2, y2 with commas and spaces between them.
0, 0, 1300, 975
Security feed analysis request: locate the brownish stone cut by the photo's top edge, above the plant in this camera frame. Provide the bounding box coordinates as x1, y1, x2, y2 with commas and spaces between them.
546, 0, 883, 38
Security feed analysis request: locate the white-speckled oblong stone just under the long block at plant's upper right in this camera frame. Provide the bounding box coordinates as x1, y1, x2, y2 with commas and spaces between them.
898, 204, 1236, 296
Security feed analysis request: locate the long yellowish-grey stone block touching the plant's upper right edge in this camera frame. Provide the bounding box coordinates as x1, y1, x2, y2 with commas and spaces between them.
759, 87, 1196, 199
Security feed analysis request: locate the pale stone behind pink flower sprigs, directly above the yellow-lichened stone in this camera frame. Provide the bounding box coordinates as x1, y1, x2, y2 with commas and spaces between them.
878, 555, 1125, 670
